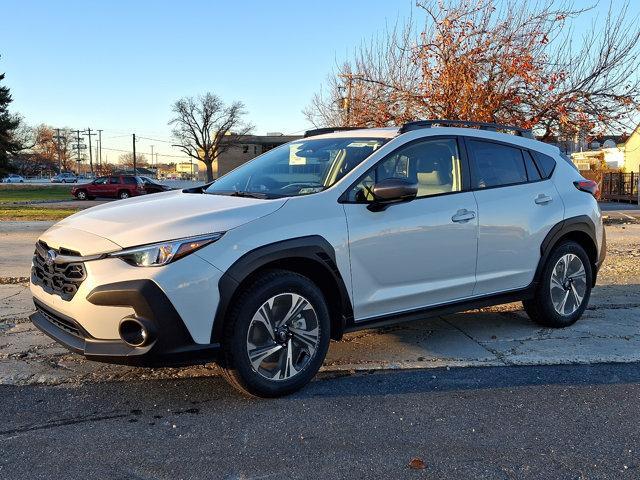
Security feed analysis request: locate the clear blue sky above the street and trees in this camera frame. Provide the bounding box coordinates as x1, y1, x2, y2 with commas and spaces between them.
0, 0, 640, 161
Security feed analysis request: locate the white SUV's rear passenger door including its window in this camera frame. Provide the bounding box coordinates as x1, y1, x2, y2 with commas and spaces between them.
465, 137, 564, 295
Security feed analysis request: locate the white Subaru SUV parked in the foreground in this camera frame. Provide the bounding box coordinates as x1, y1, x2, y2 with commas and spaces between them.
31, 120, 605, 396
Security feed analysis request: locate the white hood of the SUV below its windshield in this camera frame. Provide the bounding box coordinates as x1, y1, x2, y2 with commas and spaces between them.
50, 190, 286, 249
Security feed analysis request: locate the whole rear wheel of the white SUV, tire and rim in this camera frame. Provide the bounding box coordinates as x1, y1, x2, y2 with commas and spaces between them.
523, 242, 593, 328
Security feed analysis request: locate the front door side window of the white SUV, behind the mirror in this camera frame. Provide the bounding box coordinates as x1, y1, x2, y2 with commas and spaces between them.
347, 138, 462, 202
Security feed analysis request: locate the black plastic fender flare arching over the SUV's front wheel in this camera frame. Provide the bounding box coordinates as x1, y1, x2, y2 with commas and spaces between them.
211, 235, 353, 343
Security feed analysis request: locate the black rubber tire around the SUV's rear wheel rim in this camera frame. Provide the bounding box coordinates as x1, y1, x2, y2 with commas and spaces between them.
522, 241, 593, 328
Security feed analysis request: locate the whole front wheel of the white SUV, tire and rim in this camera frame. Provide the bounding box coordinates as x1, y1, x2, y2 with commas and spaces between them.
221, 270, 330, 397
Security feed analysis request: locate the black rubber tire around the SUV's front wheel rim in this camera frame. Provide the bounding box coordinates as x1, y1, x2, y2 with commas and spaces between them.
220, 270, 331, 397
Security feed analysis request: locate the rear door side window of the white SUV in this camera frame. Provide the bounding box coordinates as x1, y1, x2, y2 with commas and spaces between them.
467, 140, 527, 188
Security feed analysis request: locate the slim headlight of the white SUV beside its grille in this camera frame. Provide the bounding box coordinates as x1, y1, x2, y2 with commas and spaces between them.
109, 232, 224, 267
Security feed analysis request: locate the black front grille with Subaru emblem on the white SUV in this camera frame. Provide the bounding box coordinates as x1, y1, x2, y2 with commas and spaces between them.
31, 241, 87, 301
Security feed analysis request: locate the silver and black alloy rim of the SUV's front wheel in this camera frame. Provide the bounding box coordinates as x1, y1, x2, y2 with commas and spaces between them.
247, 293, 320, 381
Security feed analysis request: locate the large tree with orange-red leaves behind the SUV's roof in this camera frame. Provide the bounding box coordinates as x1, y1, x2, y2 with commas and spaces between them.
305, 0, 640, 139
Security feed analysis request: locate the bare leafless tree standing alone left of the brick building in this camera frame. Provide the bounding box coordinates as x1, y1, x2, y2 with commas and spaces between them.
169, 93, 253, 181
